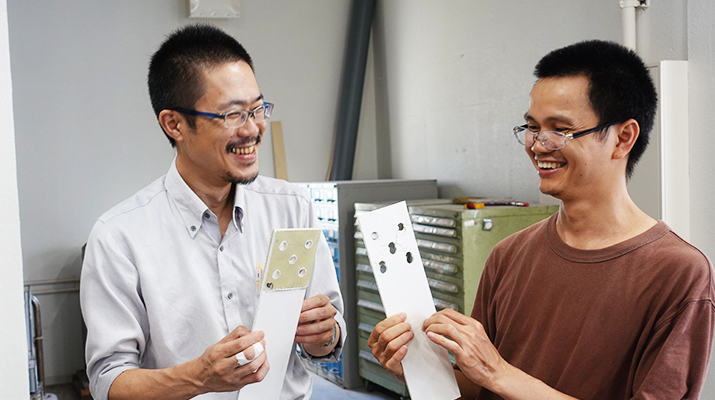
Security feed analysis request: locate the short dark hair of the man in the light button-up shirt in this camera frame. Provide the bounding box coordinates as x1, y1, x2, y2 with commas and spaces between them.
147, 24, 253, 147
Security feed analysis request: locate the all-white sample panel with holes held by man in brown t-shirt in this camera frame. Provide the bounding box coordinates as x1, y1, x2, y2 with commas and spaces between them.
357, 201, 460, 400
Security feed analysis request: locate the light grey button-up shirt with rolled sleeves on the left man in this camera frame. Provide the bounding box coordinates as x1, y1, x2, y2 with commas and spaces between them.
80, 161, 346, 400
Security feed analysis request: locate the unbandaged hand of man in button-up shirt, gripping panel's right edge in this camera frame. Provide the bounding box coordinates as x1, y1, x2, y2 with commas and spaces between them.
295, 294, 340, 357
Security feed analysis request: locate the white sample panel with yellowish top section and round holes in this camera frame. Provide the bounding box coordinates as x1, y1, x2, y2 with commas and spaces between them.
238, 229, 320, 400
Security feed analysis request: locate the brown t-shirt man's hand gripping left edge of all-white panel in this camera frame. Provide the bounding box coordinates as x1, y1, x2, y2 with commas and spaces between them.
367, 313, 415, 381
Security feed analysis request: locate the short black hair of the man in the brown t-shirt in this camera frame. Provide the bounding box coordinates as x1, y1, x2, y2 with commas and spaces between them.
534, 40, 658, 178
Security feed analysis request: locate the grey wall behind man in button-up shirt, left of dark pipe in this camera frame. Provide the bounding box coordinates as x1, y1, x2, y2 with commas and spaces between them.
8, 0, 356, 383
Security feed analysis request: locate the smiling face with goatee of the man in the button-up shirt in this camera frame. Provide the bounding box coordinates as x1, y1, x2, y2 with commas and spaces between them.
175, 61, 267, 187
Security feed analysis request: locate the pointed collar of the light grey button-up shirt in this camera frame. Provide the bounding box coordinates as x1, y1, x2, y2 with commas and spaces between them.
164, 158, 245, 238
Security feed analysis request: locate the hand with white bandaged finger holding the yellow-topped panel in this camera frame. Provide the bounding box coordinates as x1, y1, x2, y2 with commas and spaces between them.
196, 326, 270, 392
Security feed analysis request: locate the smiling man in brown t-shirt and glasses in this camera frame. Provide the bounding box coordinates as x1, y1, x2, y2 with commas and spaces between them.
369, 41, 715, 399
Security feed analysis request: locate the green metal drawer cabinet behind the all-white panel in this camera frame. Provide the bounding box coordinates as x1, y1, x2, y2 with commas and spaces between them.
355, 202, 558, 396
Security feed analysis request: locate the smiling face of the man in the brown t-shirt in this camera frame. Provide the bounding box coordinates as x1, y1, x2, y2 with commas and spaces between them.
526, 75, 615, 200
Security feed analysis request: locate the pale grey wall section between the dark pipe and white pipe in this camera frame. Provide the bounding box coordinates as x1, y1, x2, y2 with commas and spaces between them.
364, 0, 620, 202
